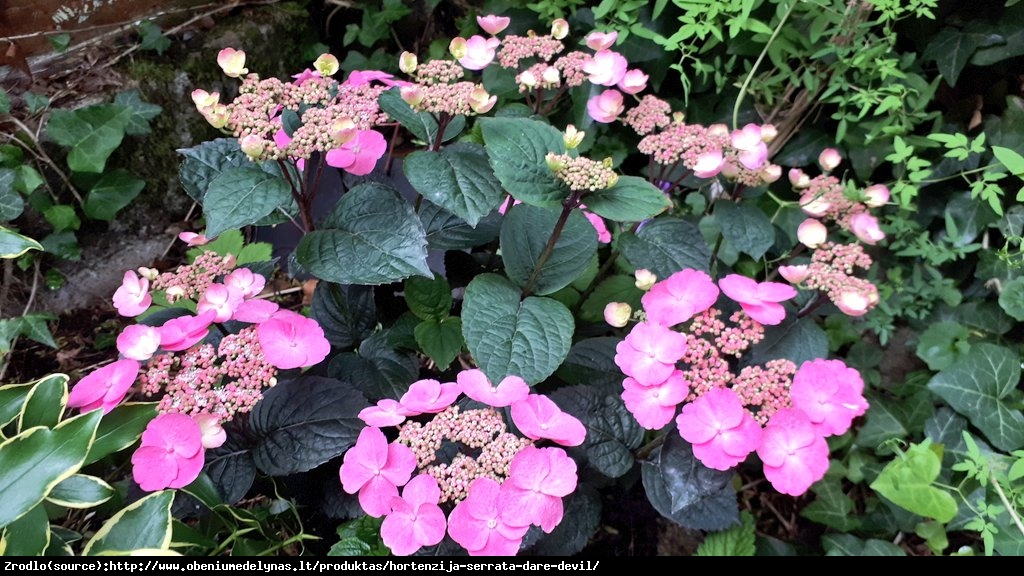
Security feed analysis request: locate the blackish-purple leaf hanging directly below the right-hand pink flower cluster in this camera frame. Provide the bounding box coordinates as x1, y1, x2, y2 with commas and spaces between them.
641, 429, 739, 530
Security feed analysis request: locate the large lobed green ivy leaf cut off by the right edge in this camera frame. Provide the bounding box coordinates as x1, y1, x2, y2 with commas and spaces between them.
928, 343, 1024, 452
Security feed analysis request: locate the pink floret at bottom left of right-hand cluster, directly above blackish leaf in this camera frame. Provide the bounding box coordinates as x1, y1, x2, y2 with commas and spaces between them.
676, 387, 762, 470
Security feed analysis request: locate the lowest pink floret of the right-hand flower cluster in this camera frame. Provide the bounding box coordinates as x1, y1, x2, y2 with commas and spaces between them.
758, 408, 828, 496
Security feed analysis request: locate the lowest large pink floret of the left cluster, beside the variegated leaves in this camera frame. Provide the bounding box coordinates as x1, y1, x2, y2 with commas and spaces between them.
131, 413, 204, 492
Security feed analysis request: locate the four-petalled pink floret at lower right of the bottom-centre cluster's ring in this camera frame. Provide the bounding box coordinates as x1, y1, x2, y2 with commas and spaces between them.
498, 446, 577, 534
